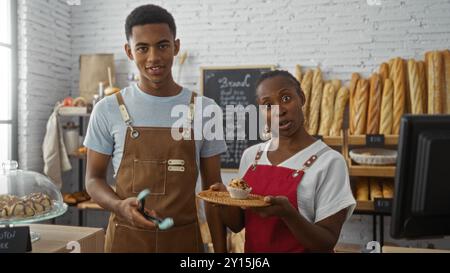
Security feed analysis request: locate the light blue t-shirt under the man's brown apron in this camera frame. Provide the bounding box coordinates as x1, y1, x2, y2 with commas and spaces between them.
84, 84, 227, 175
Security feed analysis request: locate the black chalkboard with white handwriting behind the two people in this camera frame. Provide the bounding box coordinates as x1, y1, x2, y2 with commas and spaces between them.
201, 66, 274, 170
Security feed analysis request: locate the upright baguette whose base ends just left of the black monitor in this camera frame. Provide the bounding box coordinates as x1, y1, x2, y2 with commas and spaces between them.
380, 79, 394, 135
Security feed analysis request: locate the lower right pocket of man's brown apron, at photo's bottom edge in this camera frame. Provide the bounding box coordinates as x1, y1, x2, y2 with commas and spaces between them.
156, 223, 204, 253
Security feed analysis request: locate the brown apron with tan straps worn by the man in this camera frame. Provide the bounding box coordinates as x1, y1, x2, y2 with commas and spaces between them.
105, 93, 204, 253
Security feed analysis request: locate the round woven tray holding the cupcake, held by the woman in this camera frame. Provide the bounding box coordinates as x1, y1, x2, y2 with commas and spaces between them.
197, 190, 270, 208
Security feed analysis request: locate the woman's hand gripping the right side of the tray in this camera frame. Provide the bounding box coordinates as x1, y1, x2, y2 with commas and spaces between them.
251, 196, 296, 218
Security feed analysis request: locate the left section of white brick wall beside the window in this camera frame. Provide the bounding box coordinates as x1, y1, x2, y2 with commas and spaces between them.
18, 0, 72, 172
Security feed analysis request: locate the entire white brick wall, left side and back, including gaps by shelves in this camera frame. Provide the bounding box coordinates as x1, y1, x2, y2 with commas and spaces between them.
19, 0, 450, 248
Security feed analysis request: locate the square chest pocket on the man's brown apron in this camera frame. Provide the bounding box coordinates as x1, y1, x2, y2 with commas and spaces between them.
132, 159, 167, 195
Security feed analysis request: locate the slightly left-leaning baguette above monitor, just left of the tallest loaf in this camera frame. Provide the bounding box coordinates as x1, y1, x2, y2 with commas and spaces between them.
408, 59, 425, 115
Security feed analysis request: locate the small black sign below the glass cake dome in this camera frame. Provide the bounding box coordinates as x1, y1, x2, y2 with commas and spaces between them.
0, 227, 31, 253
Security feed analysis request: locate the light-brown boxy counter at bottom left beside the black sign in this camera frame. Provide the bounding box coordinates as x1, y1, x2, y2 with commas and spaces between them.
30, 225, 105, 253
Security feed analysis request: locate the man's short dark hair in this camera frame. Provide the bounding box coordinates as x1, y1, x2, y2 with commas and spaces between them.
125, 5, 177, 41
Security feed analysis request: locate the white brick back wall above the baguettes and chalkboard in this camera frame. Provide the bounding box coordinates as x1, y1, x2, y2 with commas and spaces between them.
72, 0, 450, 92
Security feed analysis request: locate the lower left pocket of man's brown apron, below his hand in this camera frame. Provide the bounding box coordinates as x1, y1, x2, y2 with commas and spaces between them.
111, 224, 156, 253
